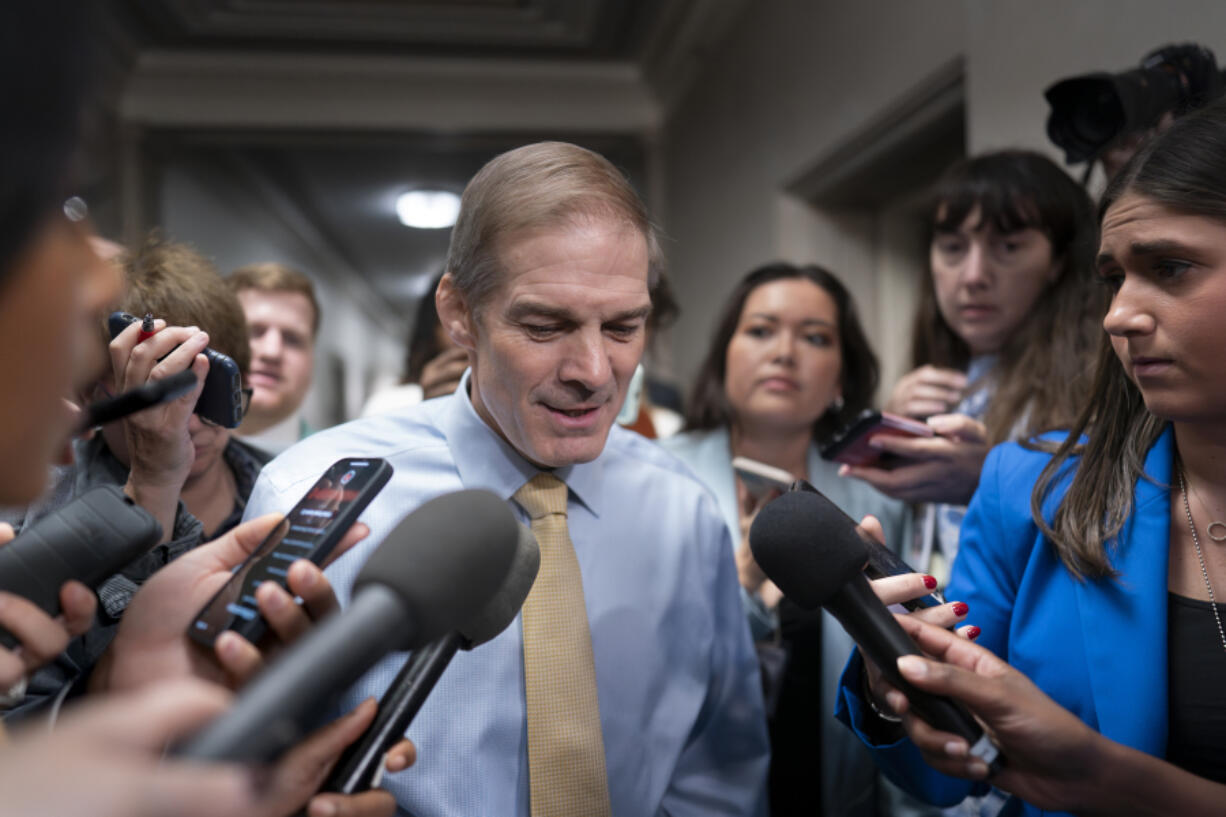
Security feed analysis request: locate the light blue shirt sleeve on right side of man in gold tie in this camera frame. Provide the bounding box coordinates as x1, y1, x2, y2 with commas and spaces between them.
661, 503, 770, 817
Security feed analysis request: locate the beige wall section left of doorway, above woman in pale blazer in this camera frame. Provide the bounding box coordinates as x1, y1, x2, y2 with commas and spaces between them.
663, 0, 962, 387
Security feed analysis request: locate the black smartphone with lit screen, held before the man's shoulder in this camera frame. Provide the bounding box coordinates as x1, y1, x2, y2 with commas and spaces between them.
188, 458, 392, 648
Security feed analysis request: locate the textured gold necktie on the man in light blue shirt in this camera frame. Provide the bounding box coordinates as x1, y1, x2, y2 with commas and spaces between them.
514, 474, 613, 817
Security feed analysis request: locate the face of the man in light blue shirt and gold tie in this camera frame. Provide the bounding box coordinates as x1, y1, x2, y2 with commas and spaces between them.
444, 217, 651, 467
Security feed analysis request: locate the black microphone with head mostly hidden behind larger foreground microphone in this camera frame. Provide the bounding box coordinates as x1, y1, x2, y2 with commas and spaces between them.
321, 517, 541, 794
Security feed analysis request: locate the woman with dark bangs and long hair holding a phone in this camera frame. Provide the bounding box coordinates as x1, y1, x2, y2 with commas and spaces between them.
840, 151, 1106, 586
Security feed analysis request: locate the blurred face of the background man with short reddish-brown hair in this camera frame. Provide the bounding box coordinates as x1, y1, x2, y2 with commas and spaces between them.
238, 290, 315, 432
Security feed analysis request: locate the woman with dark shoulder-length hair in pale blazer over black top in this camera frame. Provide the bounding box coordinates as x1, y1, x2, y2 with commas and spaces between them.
663, 263, 958, 815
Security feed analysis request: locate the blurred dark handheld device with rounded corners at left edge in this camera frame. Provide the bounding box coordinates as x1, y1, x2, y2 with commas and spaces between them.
0, 485, 162, 648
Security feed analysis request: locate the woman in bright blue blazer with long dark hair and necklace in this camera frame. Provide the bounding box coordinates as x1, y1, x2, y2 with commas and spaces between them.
840, 103, 1226, 815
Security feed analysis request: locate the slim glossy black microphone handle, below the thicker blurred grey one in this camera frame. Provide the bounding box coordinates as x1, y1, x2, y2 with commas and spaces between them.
320, 631, 463, 794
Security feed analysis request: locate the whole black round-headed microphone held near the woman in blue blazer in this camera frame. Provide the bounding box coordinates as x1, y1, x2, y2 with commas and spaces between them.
749, 491, 1004, 773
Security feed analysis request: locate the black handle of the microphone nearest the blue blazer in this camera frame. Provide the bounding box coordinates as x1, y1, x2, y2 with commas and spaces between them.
826, 574, 1004, 773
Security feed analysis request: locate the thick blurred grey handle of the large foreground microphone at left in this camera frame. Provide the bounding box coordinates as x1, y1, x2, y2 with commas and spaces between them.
174, 584, 417, 763
